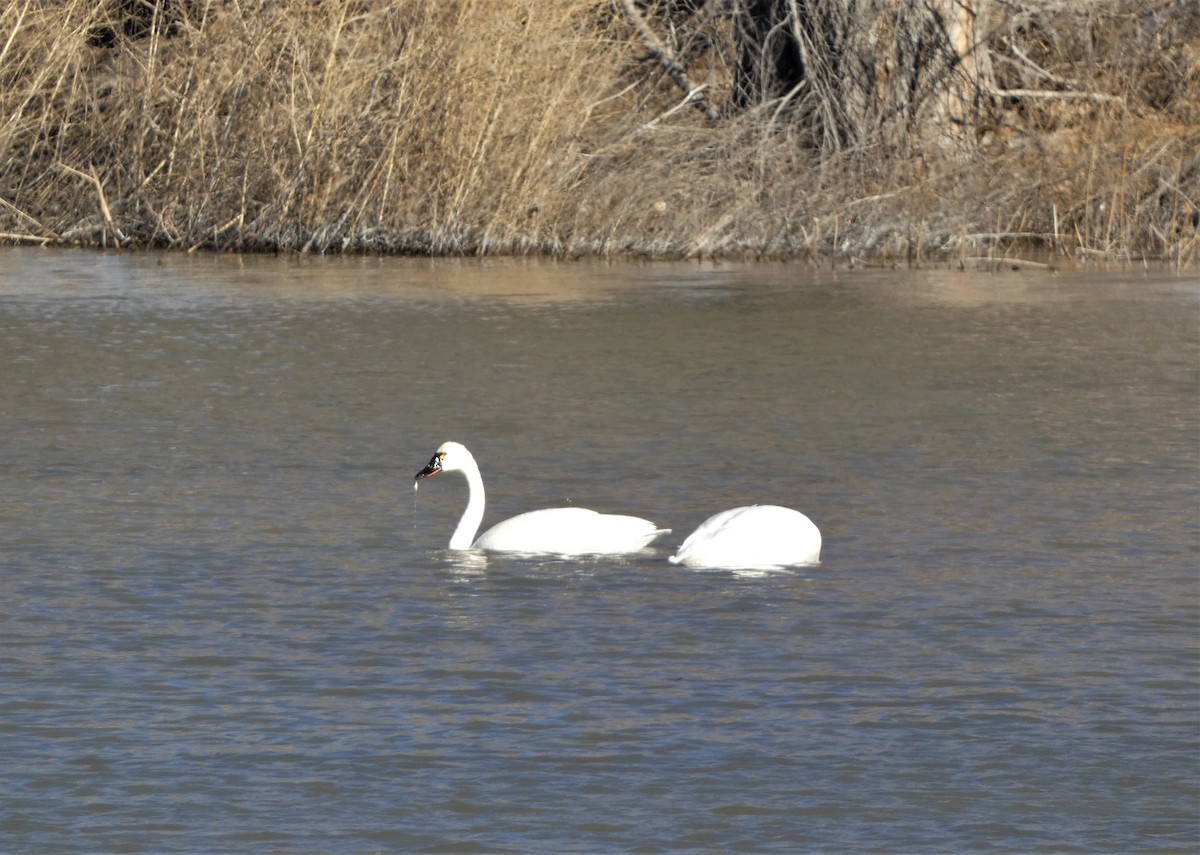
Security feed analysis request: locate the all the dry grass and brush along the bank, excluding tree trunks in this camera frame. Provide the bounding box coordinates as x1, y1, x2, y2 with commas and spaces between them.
0, 0, 1200, 264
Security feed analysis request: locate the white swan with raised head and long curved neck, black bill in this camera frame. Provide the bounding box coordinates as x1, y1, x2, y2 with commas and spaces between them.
414, 442, 671, 555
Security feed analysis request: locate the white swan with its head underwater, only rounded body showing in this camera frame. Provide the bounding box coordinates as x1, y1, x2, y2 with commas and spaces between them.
667, 504, 821, 569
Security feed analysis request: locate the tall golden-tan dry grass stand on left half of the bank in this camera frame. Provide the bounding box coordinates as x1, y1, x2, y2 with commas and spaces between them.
0, 0, 638, 252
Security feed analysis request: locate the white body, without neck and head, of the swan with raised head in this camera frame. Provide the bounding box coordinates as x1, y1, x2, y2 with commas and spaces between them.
474, 508, 671, 555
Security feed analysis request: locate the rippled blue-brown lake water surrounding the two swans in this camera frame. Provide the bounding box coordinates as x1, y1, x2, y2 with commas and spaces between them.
0, 249, 1200, 853
